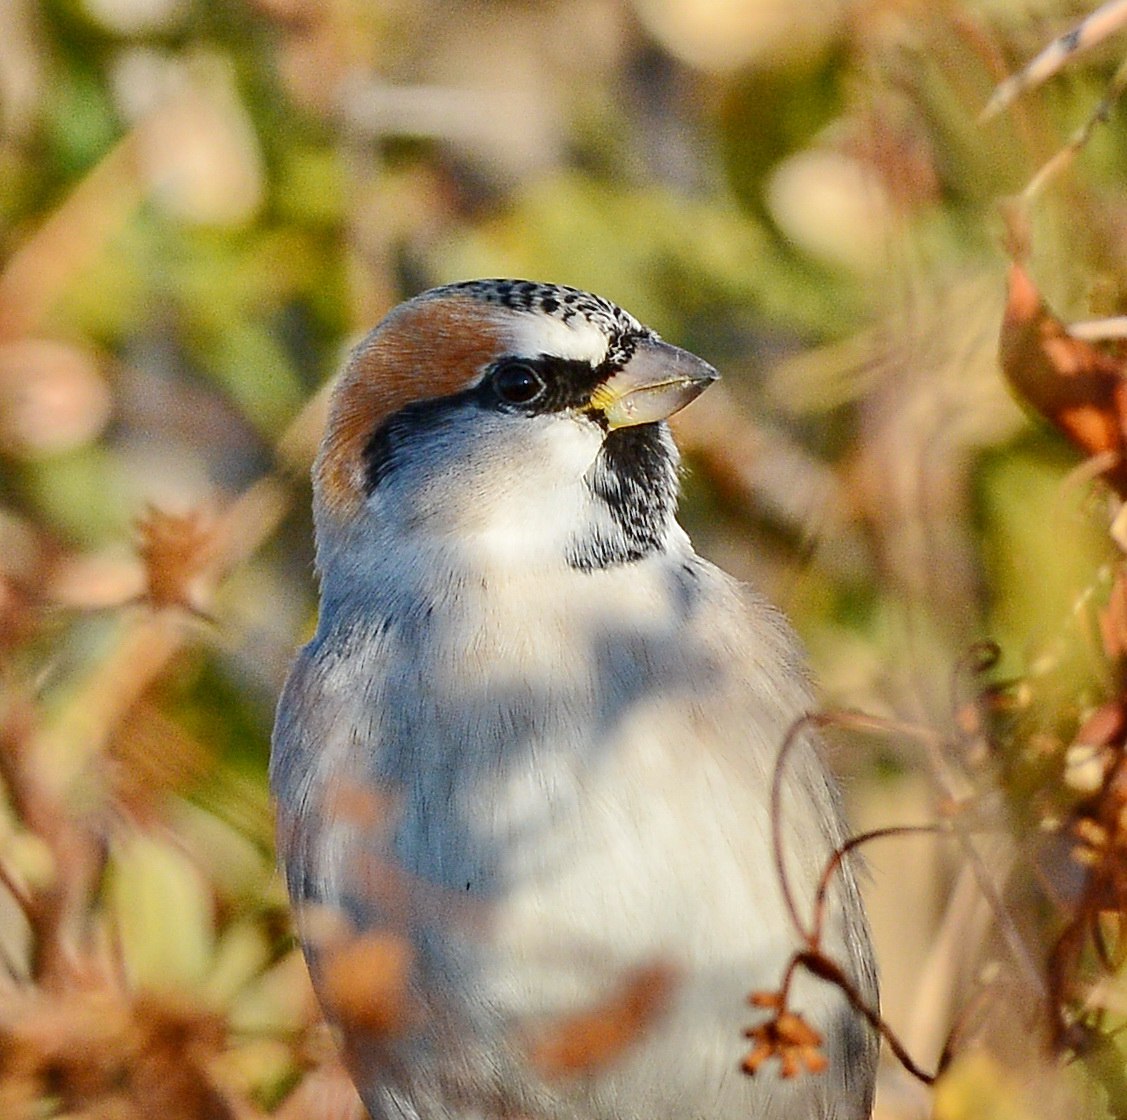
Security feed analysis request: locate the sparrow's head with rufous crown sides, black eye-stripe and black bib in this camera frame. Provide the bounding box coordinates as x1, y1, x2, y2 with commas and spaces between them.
313, 279, 717, 571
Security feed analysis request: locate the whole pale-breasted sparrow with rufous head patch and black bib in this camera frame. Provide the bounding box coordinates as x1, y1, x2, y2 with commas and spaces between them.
272, 281, 876, 1120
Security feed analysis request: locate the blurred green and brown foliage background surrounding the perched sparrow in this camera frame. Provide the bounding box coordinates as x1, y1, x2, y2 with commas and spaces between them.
0, 0, 1127, 1120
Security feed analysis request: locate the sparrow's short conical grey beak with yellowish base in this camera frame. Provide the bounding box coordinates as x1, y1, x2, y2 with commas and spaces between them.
591, 338, 720, 430
